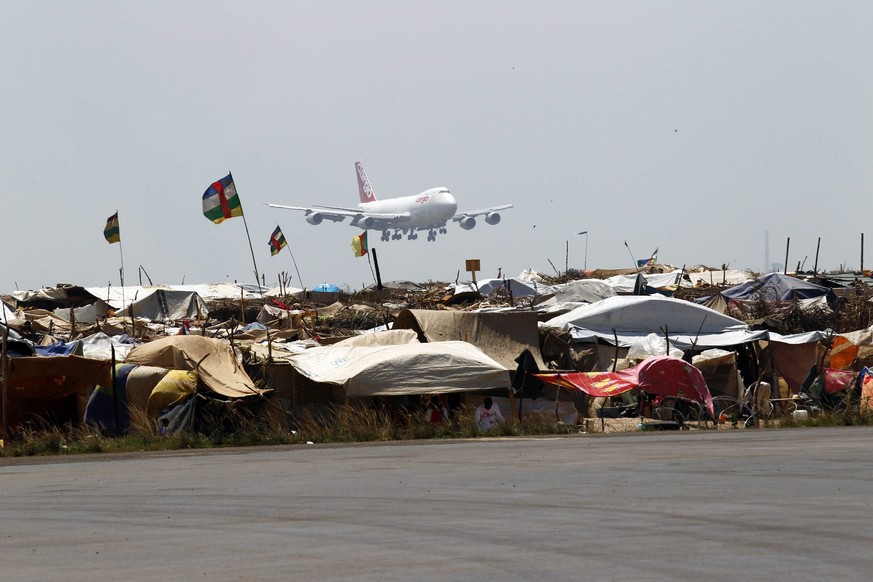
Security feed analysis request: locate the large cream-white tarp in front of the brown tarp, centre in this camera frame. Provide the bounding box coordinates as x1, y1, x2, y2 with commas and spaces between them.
287, 341, 509, 397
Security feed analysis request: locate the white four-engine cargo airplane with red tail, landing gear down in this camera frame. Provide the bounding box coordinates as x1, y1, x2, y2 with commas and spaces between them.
267, 162, 512, 242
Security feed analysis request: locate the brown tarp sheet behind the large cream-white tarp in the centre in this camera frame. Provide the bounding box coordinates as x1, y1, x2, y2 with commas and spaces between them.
393, 309, 545, 370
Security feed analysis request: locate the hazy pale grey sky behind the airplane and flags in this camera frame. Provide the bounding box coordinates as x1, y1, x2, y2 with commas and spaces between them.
0, 0, 873, 292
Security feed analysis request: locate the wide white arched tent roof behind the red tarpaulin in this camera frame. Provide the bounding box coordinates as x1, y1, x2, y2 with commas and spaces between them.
541, 295, 767, 349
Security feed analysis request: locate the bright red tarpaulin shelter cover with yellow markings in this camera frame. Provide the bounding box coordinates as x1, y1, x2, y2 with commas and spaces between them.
536, 356, 714, 417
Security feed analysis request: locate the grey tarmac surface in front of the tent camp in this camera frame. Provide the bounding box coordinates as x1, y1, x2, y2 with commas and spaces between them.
0, 428, 873, 580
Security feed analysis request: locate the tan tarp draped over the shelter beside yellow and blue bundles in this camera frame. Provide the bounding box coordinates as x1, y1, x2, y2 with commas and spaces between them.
125, 335, 263, 398
